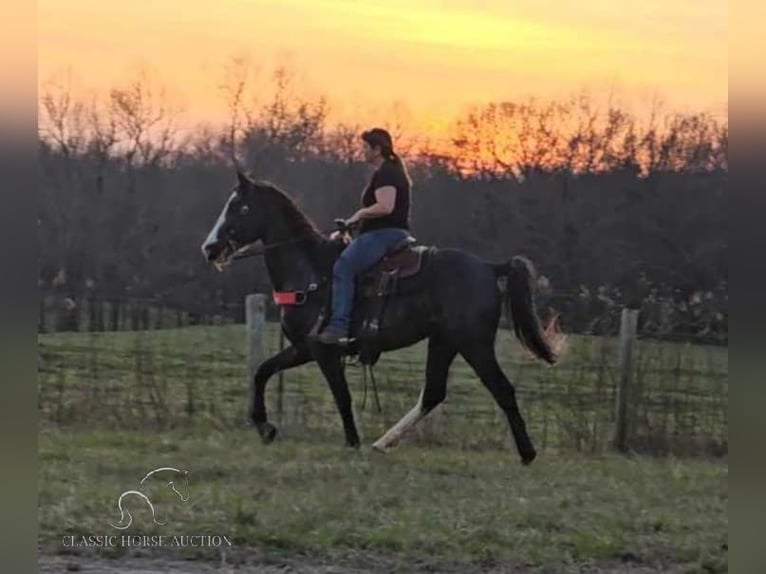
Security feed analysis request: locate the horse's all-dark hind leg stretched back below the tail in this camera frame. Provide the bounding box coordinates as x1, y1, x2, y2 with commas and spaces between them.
460, 341, 537, 465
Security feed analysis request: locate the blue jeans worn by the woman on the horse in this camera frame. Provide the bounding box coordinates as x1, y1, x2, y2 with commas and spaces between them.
328, 227, 409, 333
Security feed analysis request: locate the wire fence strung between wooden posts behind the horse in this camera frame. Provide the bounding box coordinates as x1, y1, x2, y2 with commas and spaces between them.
38, 297, 728, 456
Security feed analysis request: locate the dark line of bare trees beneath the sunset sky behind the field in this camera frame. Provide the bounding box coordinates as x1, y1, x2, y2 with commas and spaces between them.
38, 70, 728, 342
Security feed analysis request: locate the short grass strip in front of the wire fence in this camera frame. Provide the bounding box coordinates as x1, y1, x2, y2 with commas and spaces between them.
39, 430, 728, 571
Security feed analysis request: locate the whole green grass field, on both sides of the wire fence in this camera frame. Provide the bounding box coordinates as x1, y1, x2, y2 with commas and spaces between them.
39, 325, 728, 572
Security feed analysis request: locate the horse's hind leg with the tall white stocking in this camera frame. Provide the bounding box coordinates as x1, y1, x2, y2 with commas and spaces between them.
372, 337, 457, 452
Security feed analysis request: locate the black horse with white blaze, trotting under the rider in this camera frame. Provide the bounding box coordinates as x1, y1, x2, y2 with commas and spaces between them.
202, 170, 558, 464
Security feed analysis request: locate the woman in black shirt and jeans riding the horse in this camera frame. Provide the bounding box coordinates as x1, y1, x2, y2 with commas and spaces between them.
316, 128, 412, 344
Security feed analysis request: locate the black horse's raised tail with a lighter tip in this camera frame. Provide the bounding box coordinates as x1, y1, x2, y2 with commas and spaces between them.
494, 255, 563, 365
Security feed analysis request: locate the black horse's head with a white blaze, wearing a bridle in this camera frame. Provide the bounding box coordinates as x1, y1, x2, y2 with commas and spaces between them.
202, 170, 266, 271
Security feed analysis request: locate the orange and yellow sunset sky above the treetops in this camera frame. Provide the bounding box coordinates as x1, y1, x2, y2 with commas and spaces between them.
38, 0, 728, 138
